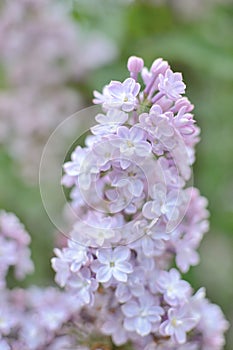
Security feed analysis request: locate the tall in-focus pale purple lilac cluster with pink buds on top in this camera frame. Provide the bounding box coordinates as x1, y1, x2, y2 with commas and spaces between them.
52, 57, 228, 350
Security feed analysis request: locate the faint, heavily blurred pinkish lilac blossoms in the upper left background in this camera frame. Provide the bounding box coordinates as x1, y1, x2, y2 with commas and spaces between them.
0, 0, 116, 181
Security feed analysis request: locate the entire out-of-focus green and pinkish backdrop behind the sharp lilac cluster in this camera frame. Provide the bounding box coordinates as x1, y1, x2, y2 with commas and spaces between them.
0, 0, 233, 350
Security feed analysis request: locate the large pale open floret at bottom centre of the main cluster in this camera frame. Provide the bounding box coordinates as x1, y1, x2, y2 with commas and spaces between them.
122, 293, 164, 337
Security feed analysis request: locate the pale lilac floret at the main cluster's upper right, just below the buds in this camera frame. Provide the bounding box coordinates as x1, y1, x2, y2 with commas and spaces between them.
158, 69, 185, 101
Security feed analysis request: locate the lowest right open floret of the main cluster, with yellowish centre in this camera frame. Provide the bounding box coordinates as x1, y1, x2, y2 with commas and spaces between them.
159, 305, 197, 344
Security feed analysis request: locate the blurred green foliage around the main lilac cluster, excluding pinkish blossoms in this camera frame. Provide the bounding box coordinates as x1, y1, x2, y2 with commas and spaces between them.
0, 0, 233, 350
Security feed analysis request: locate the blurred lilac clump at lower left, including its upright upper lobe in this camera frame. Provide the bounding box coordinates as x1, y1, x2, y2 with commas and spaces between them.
0, 211, 87, 350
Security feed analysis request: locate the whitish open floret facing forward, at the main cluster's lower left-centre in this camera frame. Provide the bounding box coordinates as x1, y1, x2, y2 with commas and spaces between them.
95, 246, 133, 283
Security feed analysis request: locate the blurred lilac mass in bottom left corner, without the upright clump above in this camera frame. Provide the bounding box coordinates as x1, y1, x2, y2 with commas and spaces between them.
0, 287, 78, 350
